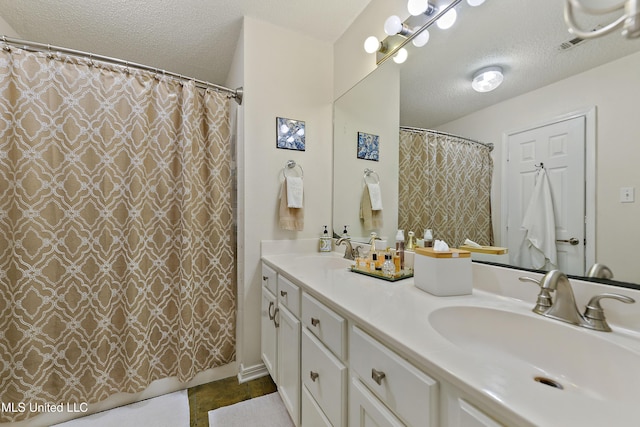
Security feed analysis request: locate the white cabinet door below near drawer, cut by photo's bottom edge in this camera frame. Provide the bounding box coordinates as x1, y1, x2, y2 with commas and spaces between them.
349, 378, 404, 427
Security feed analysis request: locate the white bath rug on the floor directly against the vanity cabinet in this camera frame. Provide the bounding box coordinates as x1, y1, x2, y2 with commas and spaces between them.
209, 392, 294, 427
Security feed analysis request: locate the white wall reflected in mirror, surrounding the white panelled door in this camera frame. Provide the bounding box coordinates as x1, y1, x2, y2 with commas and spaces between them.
439, 53, 640, 283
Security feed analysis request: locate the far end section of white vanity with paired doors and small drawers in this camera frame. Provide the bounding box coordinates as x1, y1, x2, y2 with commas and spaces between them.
261, 264, 301, 426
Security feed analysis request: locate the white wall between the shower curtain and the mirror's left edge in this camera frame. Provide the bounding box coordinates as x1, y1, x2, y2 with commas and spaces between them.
238, 17, 333, 370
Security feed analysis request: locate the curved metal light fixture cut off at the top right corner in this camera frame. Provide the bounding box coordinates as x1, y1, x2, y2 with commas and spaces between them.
564, 0, 640, 39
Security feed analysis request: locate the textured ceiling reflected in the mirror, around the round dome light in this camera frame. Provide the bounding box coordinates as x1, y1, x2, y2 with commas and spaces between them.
398, 0, 640, 128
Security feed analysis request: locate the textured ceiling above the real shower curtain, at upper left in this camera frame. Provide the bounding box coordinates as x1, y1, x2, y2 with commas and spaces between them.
0, 0, 370, 84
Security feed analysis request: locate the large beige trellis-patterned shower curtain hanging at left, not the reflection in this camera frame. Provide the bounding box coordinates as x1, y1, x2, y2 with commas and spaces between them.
0, 47, 236, 422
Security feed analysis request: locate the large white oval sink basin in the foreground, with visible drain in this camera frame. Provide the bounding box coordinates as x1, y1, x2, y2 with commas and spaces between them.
429, 306, 640, 402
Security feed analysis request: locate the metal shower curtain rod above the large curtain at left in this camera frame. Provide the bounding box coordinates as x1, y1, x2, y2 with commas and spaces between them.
1, 35, 243, 105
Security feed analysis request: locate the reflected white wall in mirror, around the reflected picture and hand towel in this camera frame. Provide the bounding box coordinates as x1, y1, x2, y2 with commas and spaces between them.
333, 61, 400, 243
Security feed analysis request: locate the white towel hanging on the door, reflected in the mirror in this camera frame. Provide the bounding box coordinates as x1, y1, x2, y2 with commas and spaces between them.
520, 169, 558, 270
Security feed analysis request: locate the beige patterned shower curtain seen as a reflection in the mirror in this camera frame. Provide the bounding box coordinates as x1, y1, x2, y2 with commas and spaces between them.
398, 128, 493, 247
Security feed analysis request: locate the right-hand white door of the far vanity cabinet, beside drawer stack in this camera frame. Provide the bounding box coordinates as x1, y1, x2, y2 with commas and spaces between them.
275, 306, 300, 426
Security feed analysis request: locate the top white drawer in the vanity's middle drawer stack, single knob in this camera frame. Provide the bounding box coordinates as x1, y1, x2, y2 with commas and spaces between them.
301, 293, 347, 360
